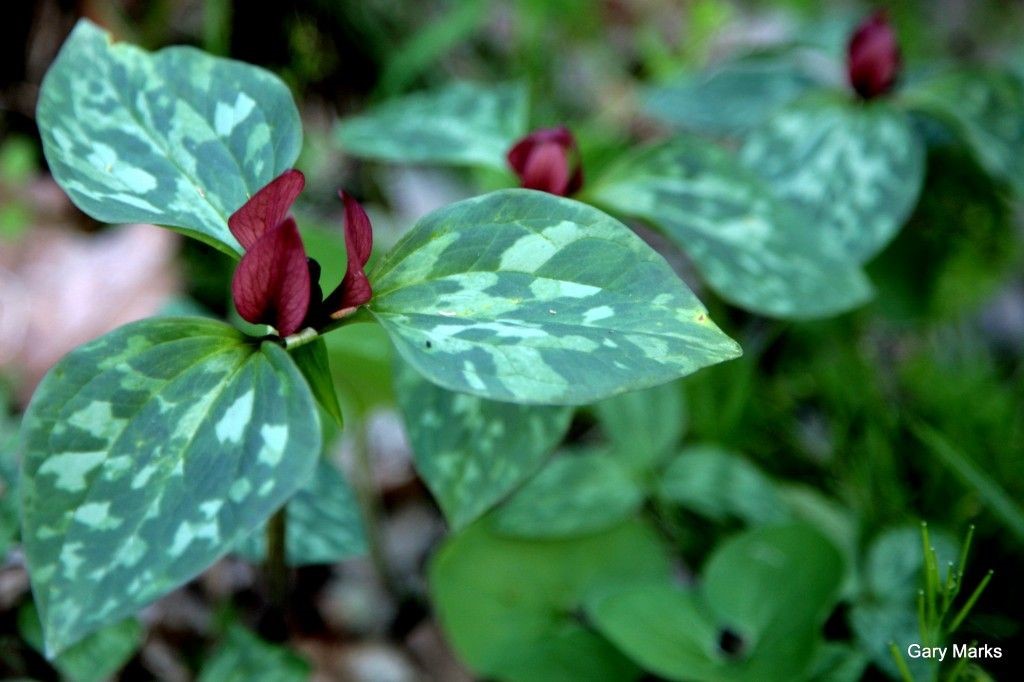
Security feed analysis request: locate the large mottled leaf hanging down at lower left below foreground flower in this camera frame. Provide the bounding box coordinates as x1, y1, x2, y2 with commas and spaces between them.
22, 317, 321, 654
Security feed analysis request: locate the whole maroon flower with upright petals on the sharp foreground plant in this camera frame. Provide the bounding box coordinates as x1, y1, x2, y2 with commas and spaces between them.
227, 169, 373, 336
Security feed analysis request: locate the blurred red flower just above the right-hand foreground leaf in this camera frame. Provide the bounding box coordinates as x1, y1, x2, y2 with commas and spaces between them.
508, 126, 583, 197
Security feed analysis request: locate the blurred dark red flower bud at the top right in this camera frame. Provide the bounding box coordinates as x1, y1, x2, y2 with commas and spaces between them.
846, 11, 901, 99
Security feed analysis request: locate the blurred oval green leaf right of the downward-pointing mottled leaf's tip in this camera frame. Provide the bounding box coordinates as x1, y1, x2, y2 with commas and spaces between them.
494, 452, 644, 538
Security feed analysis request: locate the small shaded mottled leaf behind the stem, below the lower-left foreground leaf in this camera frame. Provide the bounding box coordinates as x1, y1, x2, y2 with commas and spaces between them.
238, 458, 367, 566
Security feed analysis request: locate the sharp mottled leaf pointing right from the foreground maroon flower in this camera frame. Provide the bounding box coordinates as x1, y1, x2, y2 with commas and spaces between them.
370, 189, 739, 404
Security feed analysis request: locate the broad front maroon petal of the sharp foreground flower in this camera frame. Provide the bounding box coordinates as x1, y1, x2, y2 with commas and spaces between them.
231, 218, 309, 336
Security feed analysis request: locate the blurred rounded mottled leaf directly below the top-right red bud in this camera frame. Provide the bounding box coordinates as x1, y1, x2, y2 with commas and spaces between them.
740, 98, 925, 263
